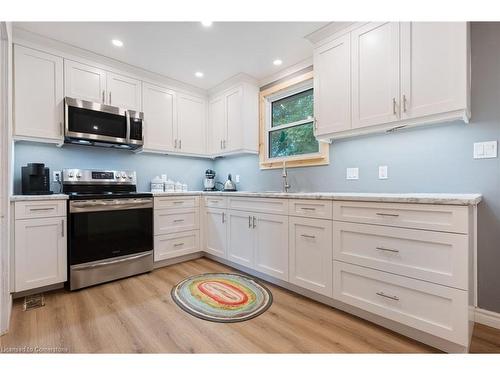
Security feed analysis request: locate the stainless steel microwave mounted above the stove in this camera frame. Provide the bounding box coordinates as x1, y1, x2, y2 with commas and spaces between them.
64, 97, 144, 149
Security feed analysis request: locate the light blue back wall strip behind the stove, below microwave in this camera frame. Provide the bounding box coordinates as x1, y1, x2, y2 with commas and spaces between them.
14, 142, 213, 193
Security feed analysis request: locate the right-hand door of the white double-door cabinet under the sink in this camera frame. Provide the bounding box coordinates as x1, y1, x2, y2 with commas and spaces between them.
254, 214, 288, 281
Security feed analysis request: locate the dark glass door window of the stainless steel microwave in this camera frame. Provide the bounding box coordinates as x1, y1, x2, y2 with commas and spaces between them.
68, 107, 127, 142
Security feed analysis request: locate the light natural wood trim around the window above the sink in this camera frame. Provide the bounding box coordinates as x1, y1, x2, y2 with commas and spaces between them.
259, 72, 330, 169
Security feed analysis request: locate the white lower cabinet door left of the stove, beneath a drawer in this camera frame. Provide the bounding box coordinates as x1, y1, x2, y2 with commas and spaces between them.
14, 217, 67, 292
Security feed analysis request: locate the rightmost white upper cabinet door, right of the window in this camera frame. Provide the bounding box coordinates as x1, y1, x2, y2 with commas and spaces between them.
401, 22, 467, 119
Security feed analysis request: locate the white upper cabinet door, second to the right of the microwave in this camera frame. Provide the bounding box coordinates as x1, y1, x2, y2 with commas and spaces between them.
177, 94, 207, 154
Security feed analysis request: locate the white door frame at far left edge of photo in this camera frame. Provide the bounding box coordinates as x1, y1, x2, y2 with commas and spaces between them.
0, 22, 12, 335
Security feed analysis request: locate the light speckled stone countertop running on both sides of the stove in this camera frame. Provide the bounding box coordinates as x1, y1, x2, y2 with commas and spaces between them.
10, 191, 482, 206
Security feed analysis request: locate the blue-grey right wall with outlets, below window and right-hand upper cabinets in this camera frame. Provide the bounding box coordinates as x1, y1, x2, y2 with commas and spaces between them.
214, 23, 500, 312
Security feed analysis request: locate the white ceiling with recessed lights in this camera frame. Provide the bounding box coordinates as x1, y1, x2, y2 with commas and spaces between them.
16, 22, 326, 89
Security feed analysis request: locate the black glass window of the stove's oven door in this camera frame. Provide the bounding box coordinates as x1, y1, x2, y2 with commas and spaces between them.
70, 208, 153, 265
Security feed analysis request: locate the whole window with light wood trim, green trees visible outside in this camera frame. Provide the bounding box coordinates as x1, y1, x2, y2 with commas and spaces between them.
260, 72, 329, 169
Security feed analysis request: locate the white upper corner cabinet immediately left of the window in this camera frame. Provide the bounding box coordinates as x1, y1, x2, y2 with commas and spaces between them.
209, 82, 259, 155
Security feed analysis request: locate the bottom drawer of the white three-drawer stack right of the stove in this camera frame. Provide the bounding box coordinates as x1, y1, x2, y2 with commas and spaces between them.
154, 230, 200, 262
